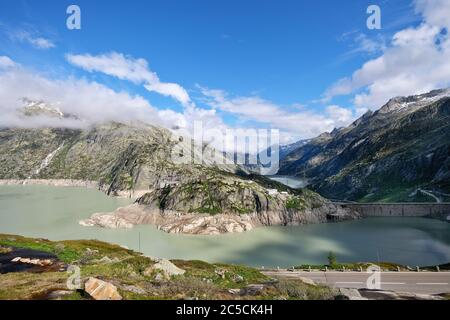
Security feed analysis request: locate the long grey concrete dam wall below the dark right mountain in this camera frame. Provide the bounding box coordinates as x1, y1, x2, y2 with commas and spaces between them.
340, 203, 450, 220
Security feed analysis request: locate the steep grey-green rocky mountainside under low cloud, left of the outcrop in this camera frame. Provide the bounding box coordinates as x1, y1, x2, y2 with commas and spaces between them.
0, 123, 237, 195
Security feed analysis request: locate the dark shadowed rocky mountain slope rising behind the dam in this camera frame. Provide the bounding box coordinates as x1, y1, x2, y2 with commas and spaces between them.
280, 89, 450, 202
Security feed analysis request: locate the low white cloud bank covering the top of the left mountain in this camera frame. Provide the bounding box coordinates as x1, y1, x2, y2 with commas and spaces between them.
0, 56, 232, 150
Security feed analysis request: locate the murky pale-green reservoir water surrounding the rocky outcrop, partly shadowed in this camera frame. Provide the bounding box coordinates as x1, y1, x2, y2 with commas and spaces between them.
0, 186, 450, 267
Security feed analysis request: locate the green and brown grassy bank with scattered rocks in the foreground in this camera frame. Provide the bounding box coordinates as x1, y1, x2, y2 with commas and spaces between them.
0, 235, 344, 300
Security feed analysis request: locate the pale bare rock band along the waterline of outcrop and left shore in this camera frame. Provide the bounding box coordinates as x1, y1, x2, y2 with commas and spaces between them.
0, 179, 360, 235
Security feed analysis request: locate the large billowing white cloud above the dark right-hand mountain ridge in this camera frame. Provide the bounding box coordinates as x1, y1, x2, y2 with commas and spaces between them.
325, 0, 450, 109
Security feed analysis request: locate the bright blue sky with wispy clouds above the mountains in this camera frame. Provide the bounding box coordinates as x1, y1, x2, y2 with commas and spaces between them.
0, 0, 449, 140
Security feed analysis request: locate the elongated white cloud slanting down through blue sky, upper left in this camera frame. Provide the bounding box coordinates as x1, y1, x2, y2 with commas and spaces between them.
66, 52, 191, 106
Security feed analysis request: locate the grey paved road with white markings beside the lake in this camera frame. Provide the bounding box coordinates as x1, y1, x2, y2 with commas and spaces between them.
263, 271, 450, 294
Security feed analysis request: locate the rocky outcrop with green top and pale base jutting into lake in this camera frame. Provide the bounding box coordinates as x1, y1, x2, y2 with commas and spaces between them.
75, 162, 359, 235
